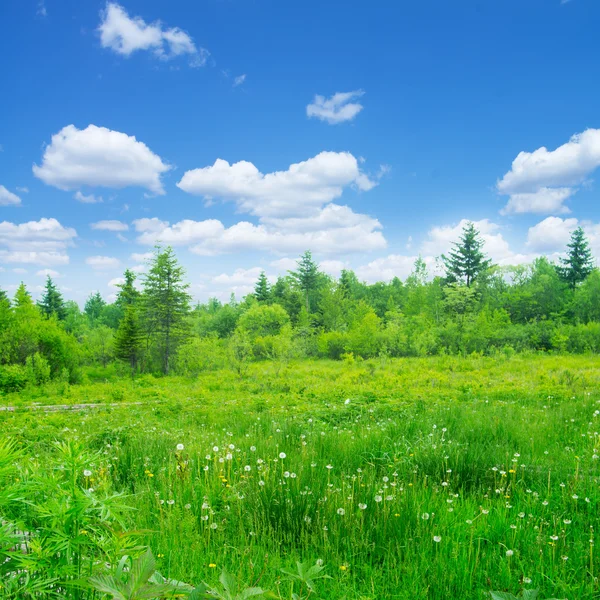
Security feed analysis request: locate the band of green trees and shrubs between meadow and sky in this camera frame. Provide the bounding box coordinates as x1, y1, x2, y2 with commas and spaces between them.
0, 224, 600, 391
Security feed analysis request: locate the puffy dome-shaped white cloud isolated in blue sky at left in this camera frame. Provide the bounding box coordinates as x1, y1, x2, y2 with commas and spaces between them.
33, 125, 171, 195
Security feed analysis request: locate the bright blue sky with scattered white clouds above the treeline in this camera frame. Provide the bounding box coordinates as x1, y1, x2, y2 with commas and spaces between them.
0, 0, 600, 302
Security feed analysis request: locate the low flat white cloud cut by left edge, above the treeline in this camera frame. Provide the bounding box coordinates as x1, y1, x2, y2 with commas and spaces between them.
0, 214, 77, 266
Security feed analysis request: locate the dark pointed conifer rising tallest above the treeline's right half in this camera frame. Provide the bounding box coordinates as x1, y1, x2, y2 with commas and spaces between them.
442, 223, 492, 287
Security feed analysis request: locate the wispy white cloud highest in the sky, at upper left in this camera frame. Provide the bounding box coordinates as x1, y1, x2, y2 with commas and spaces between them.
98, 2, 210, 67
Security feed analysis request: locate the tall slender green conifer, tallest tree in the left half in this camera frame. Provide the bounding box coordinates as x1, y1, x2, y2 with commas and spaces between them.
143, 247, 191, 374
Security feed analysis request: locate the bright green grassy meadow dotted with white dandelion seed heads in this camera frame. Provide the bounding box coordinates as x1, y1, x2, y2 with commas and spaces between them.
0, 355, 600, 600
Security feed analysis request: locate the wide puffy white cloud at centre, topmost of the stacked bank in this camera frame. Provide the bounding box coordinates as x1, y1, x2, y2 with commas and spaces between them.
177, 152, 376, 217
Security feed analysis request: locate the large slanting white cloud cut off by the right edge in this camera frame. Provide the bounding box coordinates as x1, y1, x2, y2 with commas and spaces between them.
497, 129, 600, 213
